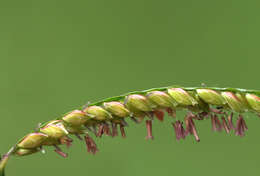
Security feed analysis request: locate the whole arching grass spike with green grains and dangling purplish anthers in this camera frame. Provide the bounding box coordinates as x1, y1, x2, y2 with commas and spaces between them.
0, 86, 260, 176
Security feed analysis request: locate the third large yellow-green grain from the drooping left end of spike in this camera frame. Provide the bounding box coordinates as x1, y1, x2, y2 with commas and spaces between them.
62, 110, 90, 126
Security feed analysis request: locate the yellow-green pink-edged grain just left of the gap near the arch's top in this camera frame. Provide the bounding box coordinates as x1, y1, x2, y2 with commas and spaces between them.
168, 88, 198, 106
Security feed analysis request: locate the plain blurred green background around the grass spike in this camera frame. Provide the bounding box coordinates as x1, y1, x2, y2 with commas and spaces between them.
0, 0, 260, 176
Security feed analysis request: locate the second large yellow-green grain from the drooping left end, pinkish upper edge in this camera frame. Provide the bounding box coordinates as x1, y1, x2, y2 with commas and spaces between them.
40, 120, 69, 139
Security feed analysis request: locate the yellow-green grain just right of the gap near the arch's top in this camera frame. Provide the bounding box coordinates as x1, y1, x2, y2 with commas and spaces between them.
196, 89, 225, 106
